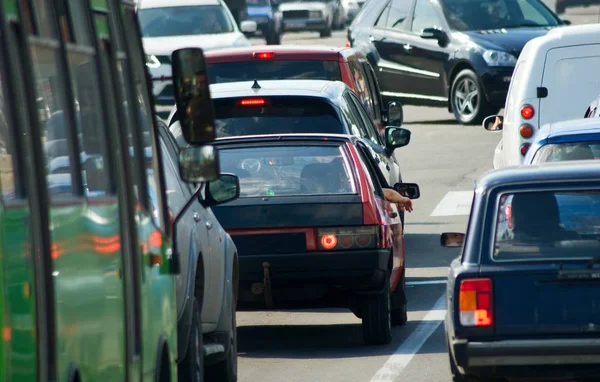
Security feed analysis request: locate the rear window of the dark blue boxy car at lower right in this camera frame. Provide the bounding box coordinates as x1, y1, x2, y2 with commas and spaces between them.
493, 191, 600, 260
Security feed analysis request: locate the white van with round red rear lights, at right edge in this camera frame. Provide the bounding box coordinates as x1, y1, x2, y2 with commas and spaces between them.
483, 24, 600, 168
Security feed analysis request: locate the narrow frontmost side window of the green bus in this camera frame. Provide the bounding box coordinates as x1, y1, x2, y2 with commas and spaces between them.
124, 8, 164, 228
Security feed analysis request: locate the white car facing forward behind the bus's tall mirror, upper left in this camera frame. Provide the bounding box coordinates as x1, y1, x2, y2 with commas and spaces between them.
138, 0, 257, 117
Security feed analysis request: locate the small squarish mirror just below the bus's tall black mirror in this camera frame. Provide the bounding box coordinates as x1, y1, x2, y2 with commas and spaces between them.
179, 145, 221, 183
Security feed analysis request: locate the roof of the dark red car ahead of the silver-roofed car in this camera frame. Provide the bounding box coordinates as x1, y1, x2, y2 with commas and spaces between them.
205, 45, 365, 64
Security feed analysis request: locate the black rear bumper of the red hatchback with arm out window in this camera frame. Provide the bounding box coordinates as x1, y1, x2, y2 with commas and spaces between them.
239, 249, 390, 292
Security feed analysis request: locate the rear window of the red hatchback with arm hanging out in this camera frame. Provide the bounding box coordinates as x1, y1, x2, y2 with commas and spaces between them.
219, 146, 356, 198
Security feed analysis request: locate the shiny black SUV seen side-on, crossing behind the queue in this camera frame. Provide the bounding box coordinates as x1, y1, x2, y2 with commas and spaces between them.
348, 0, 565, 124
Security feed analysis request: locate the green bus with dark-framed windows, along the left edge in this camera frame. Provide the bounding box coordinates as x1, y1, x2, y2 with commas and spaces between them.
0, 0, 218, 382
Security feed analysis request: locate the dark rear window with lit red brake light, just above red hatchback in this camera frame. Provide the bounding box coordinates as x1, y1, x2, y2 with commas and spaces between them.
214, 97, 344, 137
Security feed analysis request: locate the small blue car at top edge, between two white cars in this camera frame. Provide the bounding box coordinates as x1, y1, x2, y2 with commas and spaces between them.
246, 0, 283, 45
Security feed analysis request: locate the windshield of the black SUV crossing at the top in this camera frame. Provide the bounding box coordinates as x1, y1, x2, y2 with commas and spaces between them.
442, 0, 559, 31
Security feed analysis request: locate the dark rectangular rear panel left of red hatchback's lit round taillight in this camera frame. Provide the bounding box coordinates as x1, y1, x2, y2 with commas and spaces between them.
231, 232, 306, 256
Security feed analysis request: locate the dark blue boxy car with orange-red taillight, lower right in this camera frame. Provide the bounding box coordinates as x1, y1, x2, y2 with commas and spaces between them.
441, 161, 600, 381
